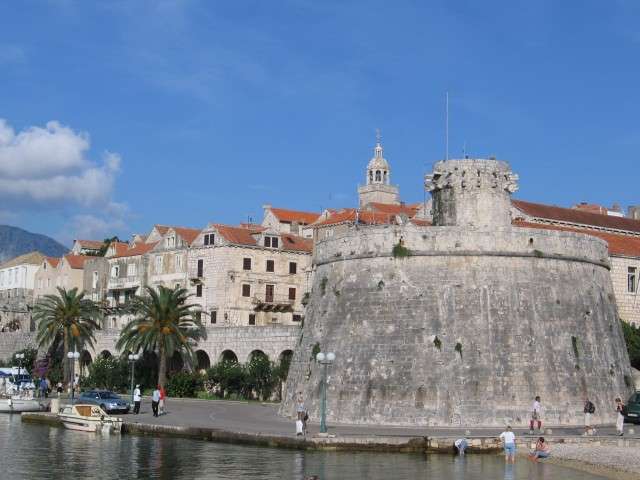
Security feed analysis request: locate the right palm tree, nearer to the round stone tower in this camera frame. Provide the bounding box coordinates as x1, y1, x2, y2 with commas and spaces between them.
116, 285, 207, 387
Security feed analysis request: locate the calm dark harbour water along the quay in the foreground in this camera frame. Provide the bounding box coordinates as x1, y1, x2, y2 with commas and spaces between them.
0, 415, 602, 480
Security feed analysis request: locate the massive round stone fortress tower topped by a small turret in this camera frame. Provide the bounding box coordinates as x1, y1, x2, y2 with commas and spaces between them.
281, 158, 631, 427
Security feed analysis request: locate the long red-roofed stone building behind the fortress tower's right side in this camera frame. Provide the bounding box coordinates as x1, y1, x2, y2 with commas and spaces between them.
511, 200, 640, 325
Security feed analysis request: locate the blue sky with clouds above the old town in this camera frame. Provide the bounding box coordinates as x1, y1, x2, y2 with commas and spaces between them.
0, 0, 640, 245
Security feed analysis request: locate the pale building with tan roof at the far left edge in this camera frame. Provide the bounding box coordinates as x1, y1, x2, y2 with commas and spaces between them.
0, 252, 44, 332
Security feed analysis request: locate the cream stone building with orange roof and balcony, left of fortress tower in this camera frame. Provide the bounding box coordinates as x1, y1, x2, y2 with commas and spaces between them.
189, 224, 312, 326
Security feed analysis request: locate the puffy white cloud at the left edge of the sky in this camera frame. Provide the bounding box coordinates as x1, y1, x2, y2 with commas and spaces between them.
0, 119, 120, 207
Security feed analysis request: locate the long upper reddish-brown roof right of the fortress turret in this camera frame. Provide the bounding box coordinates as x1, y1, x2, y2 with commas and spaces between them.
511, 200, 640, 233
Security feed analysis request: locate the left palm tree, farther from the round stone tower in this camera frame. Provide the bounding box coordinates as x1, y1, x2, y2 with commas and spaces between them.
33, 287, 99, 381
